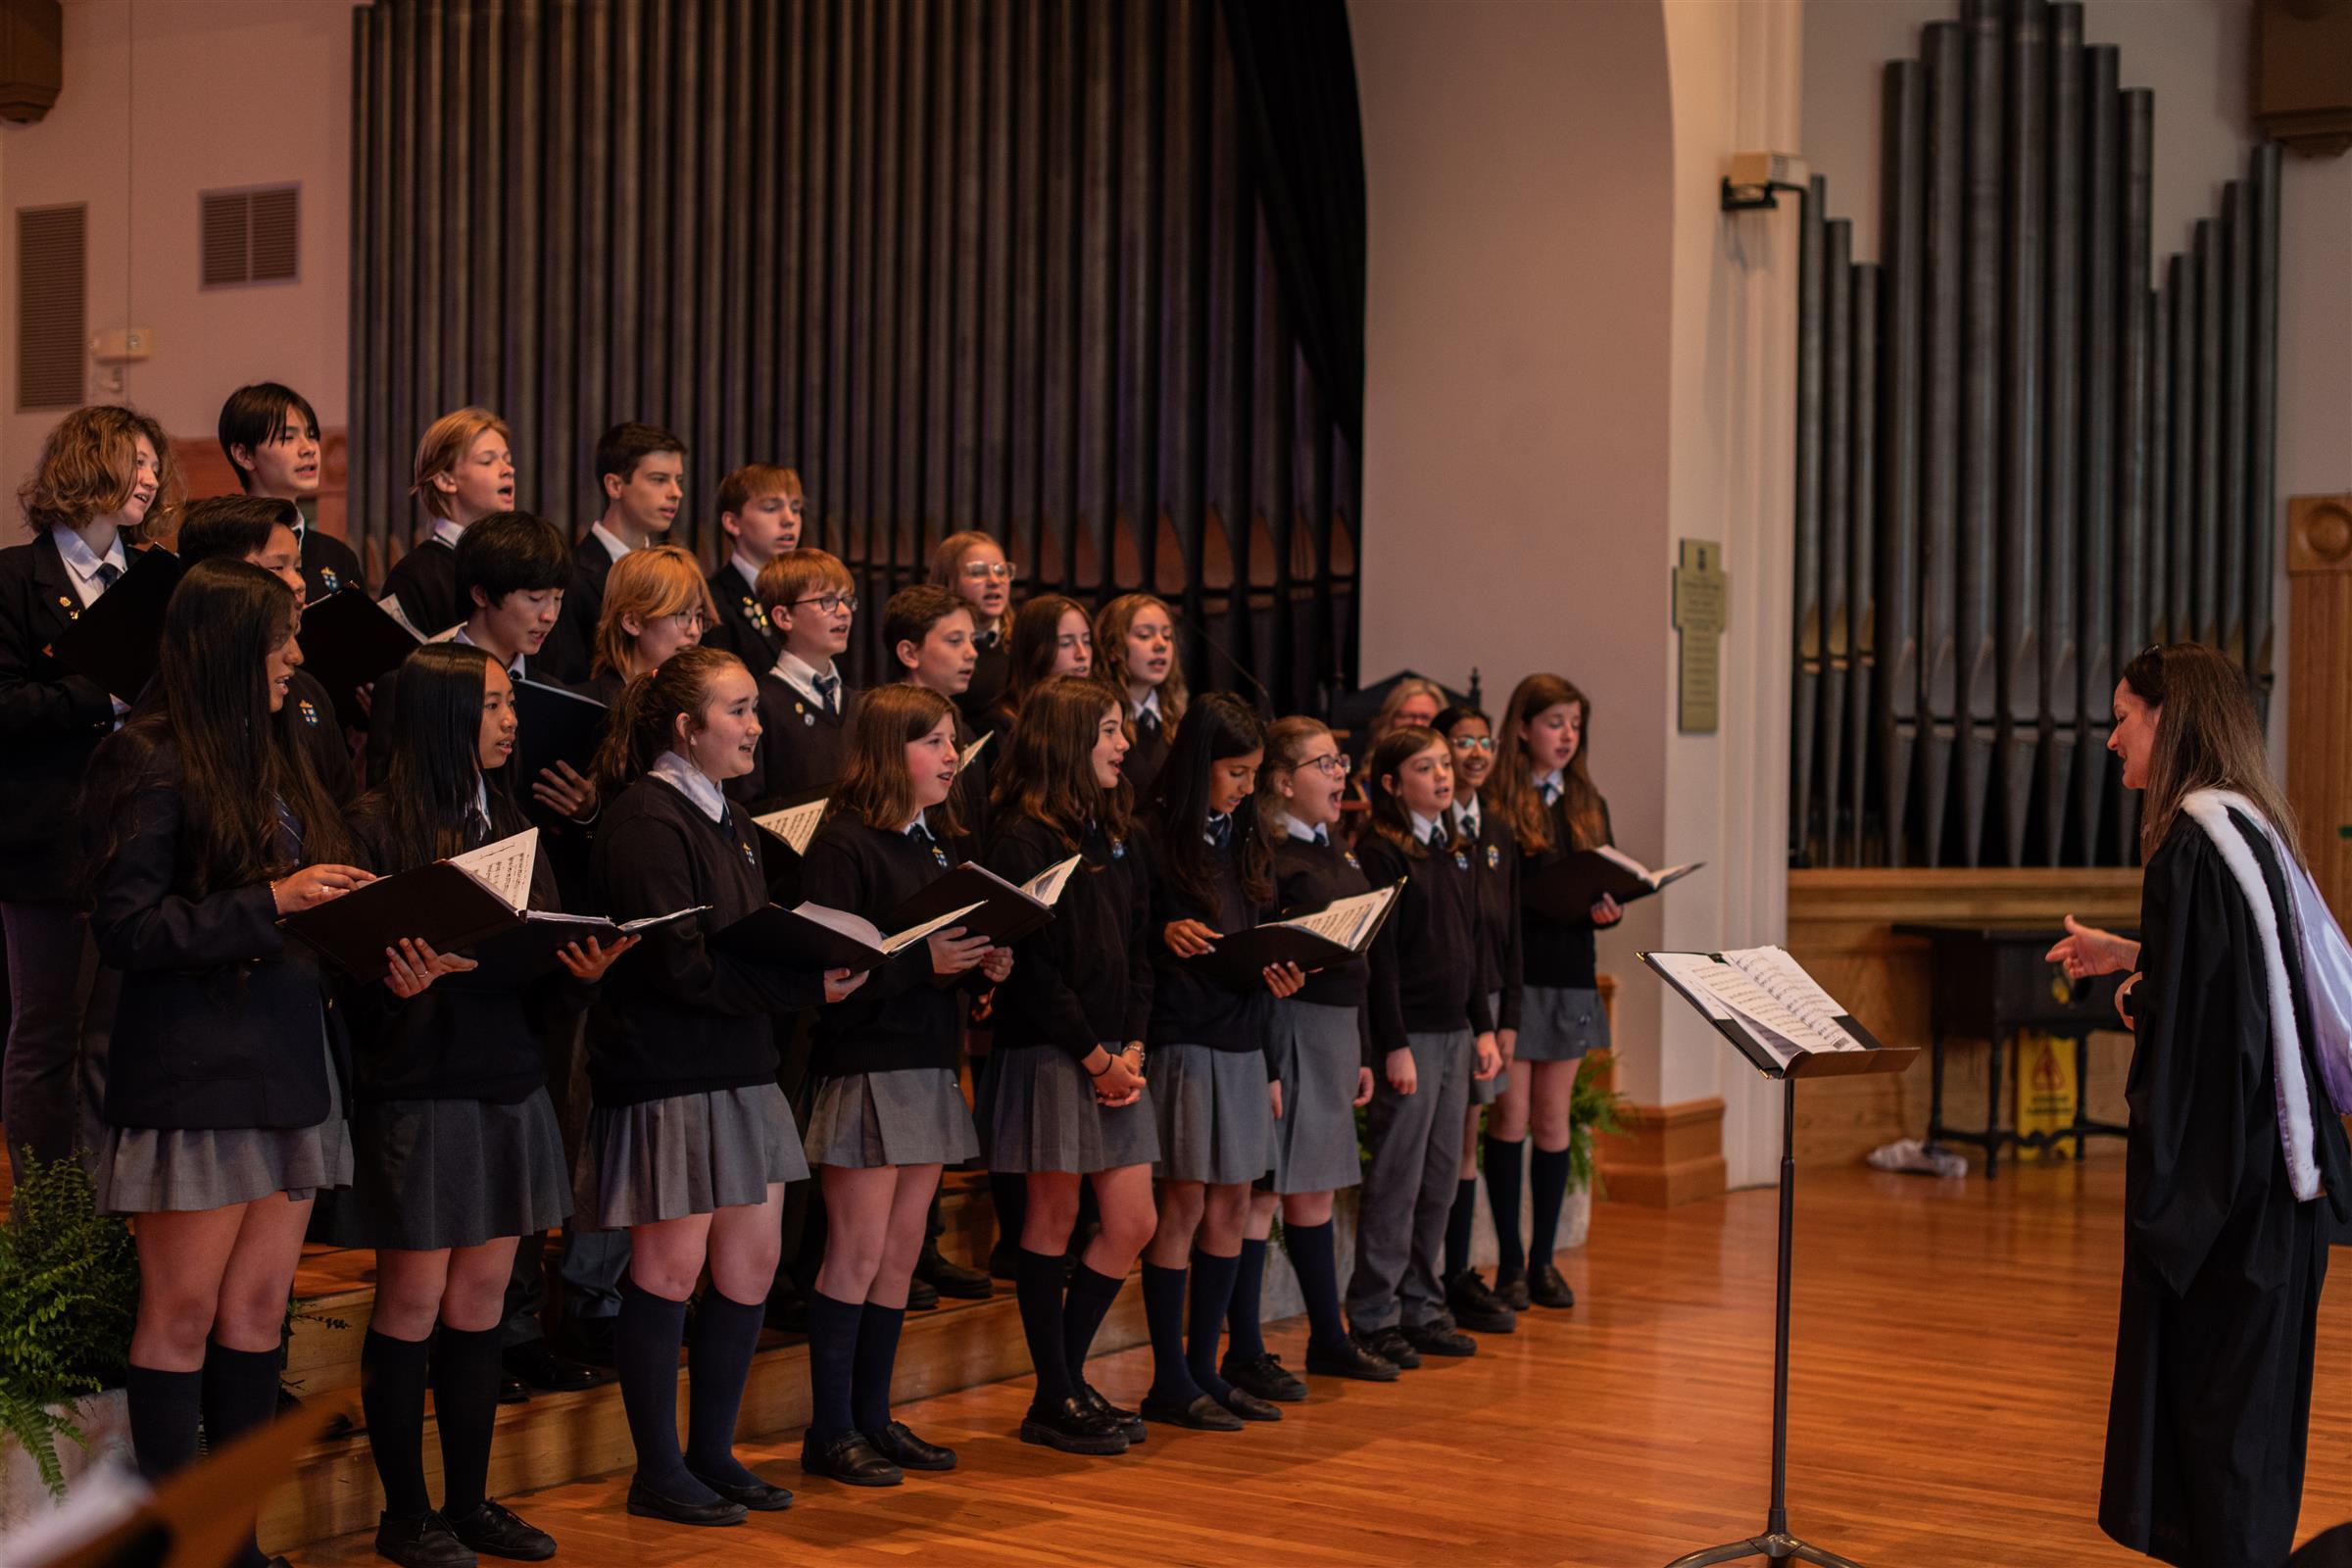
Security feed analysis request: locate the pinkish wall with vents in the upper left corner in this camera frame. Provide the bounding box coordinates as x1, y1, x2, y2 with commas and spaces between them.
0, 0, 351, 538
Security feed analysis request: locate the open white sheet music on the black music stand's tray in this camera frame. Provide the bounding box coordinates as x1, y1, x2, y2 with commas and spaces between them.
1642, 948, 1917, 1077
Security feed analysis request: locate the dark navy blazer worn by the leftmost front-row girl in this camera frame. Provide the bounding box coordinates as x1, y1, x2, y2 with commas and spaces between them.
82, 712, 346, 1128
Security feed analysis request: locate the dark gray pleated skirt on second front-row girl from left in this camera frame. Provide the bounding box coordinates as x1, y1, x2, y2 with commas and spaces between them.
327, 1086, 571, 1253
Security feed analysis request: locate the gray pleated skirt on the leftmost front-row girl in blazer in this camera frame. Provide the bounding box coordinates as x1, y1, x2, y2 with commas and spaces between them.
96, 1034, 351, 1213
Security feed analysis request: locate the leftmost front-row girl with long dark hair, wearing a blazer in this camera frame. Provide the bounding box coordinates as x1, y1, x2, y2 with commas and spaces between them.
82, 560, 412, 1563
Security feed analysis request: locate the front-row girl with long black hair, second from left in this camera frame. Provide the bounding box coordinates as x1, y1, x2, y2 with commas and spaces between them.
339, 642, 637, 1568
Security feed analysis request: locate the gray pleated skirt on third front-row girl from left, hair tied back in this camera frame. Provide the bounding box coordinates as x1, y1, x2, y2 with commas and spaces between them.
574, 1084, 809, 1230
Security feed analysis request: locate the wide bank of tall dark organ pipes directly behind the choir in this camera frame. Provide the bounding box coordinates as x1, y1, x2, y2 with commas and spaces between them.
351, 0, 1364, 710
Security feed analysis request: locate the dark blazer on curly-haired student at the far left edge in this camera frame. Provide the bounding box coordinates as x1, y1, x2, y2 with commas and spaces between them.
0, 531, 116, 903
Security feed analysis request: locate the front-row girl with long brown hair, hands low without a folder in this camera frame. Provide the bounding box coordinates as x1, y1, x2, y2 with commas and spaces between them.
988, 681, 1159, 1452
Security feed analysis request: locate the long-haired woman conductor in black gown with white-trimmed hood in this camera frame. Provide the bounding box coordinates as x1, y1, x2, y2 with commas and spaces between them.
2048, 644, 2352, 1568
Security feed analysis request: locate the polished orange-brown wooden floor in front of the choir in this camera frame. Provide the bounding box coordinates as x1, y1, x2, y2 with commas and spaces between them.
294, 1152, 2352, 1568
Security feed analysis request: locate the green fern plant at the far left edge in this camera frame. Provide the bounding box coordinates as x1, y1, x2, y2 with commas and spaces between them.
0, 1150, 139, 1497
